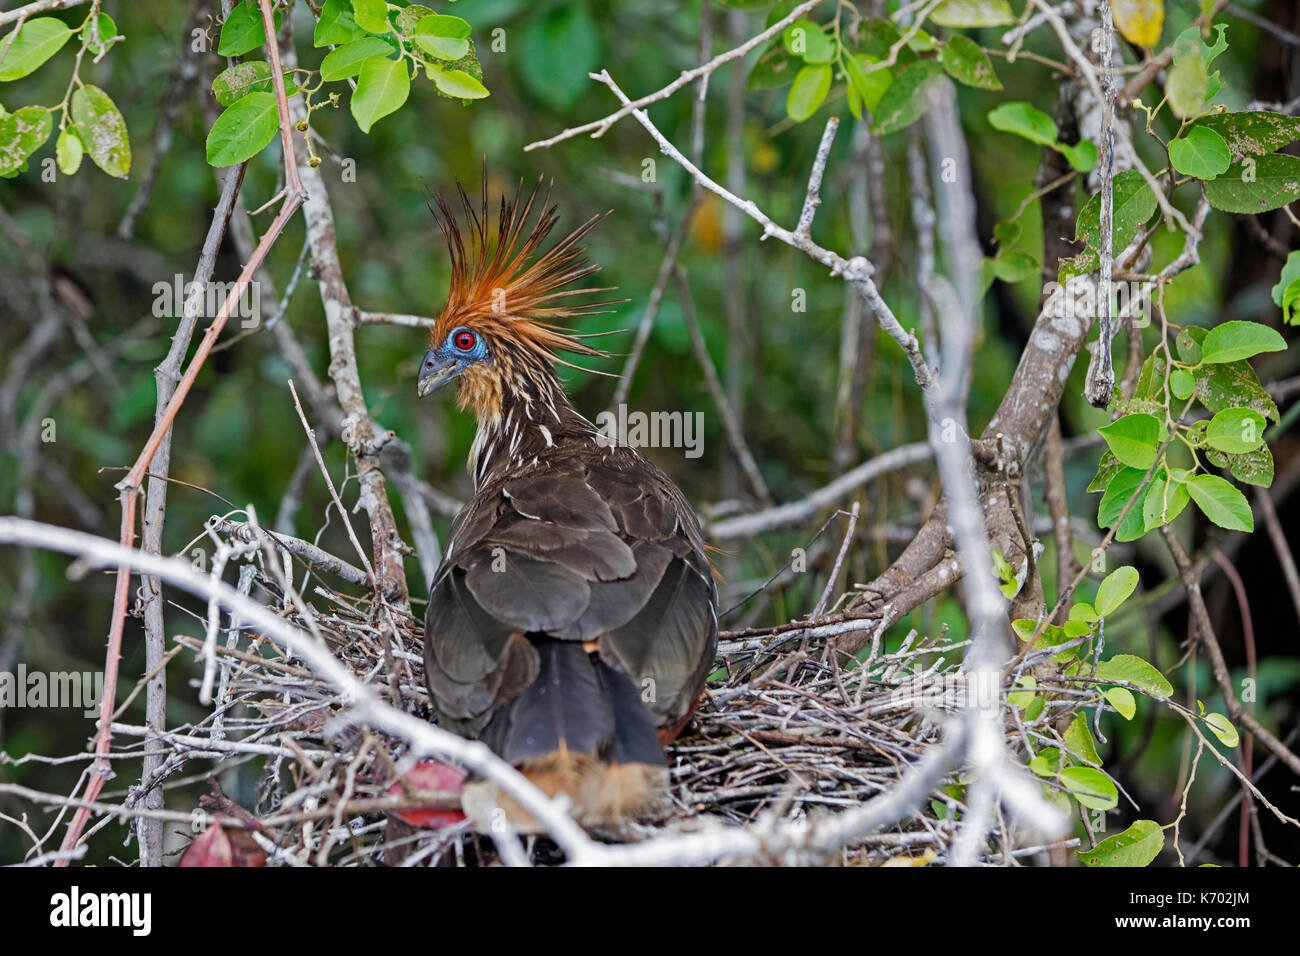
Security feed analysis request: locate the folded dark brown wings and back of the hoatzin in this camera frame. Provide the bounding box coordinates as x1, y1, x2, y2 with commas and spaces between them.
425, 446, 718, 736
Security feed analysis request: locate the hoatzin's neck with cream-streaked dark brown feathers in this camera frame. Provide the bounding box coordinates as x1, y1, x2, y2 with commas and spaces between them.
468, 348, 597, 488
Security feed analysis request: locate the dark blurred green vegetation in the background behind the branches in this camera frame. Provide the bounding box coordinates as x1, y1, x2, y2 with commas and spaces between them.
0, 0, 1300, 861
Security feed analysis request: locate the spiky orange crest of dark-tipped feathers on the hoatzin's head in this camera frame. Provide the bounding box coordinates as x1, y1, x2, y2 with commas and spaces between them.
429, 176, 625, 371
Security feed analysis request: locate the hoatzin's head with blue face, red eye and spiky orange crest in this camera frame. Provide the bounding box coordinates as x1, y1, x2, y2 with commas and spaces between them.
416, 181, 614, 420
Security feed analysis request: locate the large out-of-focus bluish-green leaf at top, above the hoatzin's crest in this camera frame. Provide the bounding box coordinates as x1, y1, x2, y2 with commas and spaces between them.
511, 4, 601, 112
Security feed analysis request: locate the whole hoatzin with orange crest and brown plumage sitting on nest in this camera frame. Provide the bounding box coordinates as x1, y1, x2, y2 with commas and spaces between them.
417, 182, 718, 831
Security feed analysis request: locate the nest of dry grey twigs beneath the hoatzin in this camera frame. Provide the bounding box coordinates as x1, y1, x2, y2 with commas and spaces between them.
91, 515, 1045, 866
